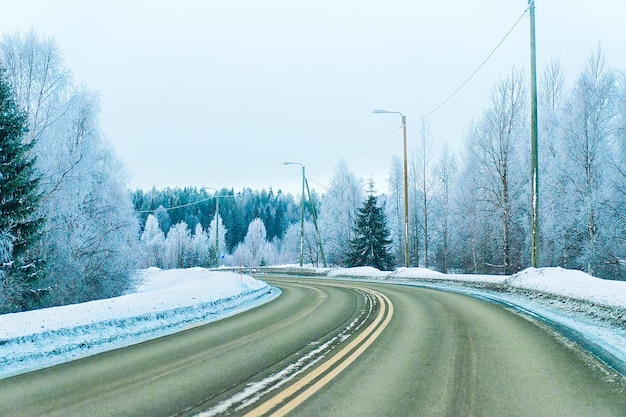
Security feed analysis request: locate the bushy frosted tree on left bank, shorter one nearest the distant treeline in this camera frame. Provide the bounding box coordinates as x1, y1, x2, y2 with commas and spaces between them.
35, 90, 139, 305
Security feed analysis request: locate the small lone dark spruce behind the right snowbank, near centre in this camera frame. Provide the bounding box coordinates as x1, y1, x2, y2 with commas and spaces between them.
348, 188, 393, 271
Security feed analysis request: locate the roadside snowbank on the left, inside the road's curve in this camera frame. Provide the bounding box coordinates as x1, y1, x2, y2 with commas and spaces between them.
0, 268, 279, 378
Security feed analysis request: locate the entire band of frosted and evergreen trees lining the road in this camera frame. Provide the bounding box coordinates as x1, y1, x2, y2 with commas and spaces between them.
0, 32, 626, 313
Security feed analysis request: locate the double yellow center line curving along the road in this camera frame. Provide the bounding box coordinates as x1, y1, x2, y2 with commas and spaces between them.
245, 290, 393, 417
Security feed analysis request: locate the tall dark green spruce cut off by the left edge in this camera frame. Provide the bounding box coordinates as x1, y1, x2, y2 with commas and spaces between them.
0, 68, 43, 312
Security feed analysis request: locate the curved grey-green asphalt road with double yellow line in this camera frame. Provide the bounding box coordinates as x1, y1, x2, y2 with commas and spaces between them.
0, 278, 626, 417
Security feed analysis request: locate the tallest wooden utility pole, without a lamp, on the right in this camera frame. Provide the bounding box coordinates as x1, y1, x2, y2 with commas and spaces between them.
528, 0, 539, 268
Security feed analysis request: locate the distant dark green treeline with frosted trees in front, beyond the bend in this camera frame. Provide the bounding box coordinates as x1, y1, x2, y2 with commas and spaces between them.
133, 188, 326, 268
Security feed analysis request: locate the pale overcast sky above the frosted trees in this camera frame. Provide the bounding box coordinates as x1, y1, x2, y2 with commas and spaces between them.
0, 0, 626, 193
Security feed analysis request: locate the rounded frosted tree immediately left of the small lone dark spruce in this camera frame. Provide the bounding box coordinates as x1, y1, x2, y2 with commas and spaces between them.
319, 161, 363, 265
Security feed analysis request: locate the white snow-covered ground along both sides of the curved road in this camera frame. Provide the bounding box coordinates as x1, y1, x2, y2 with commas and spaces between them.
0, 266, 626, 378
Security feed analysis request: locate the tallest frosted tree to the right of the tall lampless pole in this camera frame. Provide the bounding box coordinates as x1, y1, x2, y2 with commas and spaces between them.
562, 51, 618, 274
